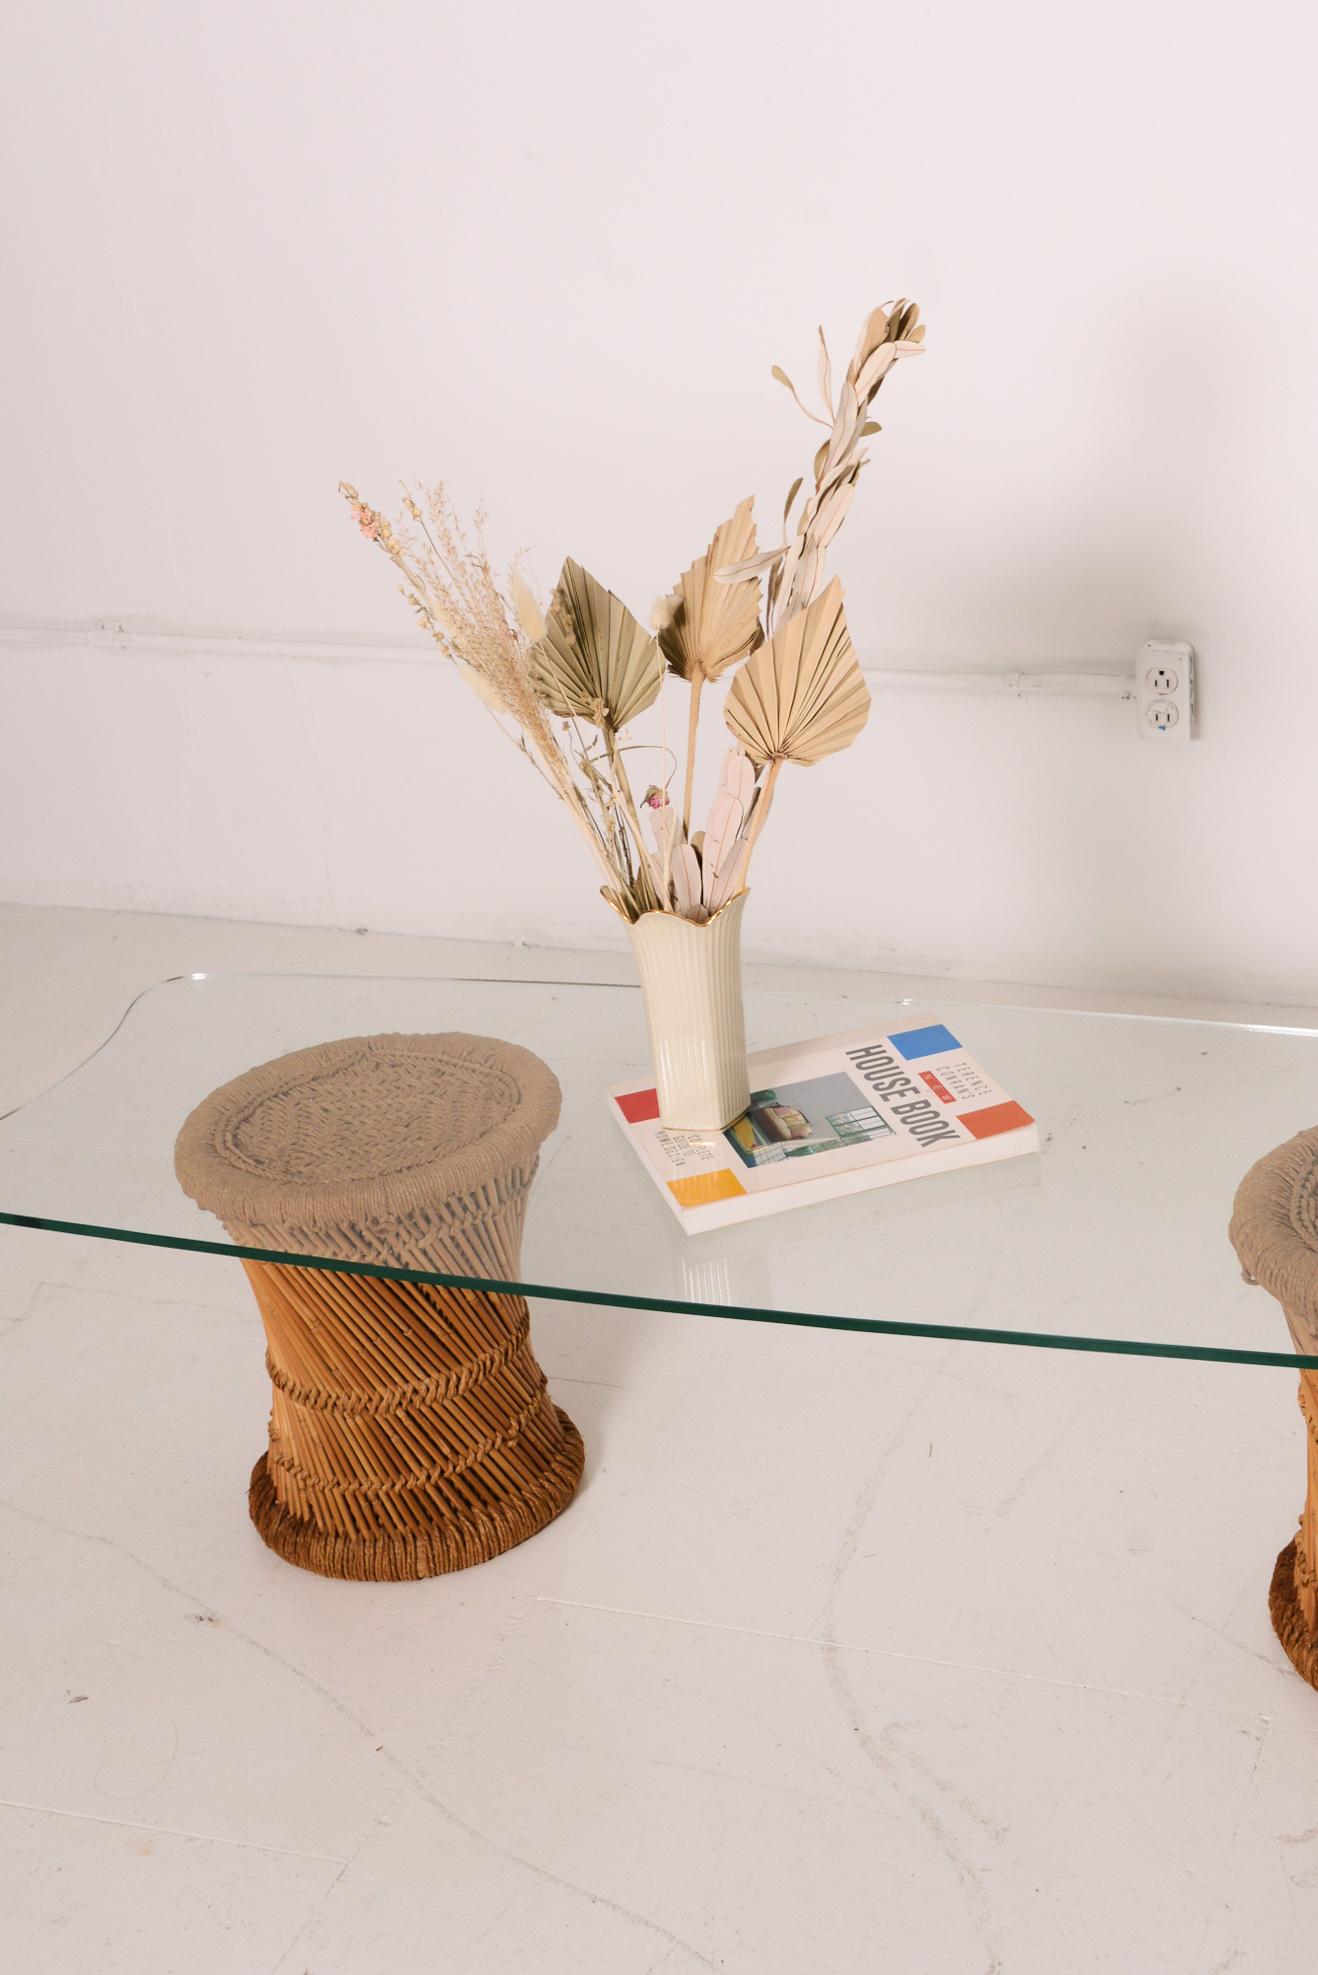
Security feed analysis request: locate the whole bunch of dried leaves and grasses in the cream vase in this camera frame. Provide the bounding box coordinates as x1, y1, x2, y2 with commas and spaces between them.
340, 300, 925, 924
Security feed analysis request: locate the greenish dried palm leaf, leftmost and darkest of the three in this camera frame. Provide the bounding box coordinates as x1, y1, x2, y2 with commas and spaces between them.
534, 557, 664, 733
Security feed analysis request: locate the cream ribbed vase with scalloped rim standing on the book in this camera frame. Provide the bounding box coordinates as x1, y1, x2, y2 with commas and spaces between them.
628, 891, 751, 1132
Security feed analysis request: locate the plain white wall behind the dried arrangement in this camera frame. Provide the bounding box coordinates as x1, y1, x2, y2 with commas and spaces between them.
0, 0, 1318, 999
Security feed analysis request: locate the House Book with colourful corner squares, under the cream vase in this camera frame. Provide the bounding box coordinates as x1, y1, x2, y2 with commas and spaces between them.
609, 1017, 1039, 1234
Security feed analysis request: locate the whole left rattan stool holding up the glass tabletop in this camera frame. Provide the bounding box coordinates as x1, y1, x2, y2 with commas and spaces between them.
174, 1033, 583, 1580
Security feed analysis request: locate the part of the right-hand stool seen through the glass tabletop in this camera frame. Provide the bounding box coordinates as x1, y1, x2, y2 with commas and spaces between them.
1231, 1128, 1318, 1377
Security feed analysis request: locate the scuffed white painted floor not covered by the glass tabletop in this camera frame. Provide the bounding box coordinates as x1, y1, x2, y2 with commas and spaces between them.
0, 909, 1318, 1975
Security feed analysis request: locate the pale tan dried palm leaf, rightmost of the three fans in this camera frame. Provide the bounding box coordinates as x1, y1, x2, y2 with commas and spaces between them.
723, 577, 869, 768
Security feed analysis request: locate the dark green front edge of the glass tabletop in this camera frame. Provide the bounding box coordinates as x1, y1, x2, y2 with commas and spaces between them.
0, 1211, 1318, 1371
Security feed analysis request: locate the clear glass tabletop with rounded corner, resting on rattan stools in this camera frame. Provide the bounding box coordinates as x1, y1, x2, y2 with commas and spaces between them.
0, 974, 1318, 1369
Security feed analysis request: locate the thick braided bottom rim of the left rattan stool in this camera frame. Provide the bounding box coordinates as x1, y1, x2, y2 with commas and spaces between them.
247, 1406, 585, 1584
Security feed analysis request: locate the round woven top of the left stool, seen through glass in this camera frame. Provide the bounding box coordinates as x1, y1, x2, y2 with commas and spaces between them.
174, 1035, 559, 1228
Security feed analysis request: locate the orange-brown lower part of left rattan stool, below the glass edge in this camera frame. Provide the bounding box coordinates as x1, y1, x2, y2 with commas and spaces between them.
243, 1262, 583, 1580
